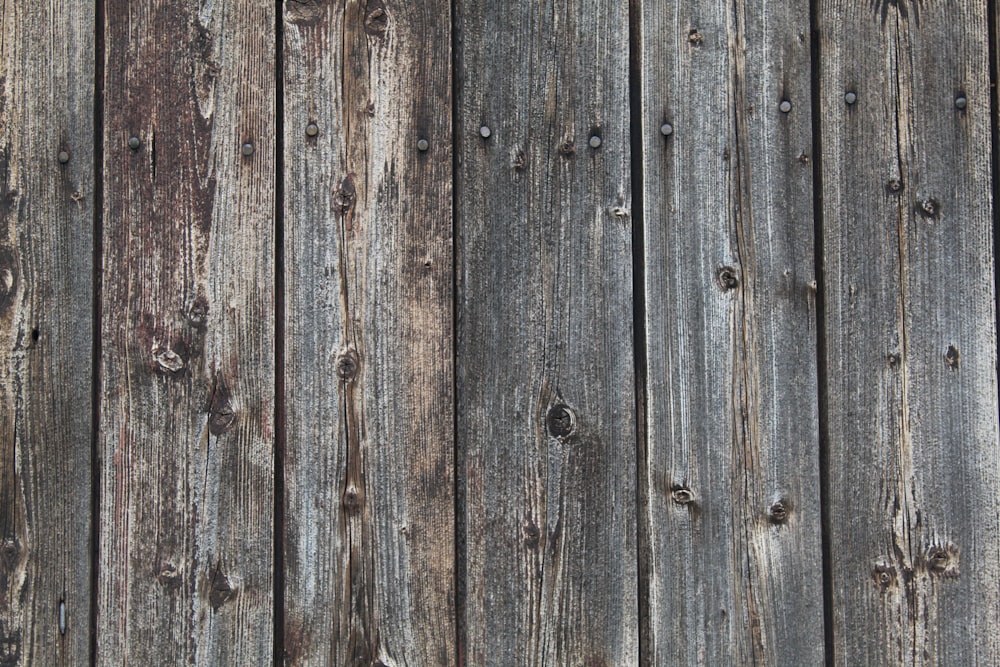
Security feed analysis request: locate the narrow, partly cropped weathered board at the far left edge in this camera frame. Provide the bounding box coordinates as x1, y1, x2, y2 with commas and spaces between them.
0, 0, 94, 665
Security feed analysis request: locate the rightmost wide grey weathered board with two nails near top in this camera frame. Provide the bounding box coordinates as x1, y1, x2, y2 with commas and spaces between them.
818, 0, 1000, 665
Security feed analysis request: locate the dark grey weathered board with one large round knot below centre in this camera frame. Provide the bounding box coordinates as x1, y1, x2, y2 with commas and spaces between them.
456, 0, 639, 665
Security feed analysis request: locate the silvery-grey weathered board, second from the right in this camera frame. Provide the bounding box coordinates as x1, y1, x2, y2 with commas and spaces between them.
636, 0, 823, 665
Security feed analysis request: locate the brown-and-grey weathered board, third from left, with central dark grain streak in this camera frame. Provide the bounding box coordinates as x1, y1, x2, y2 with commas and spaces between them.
284, 0, 457, 666
